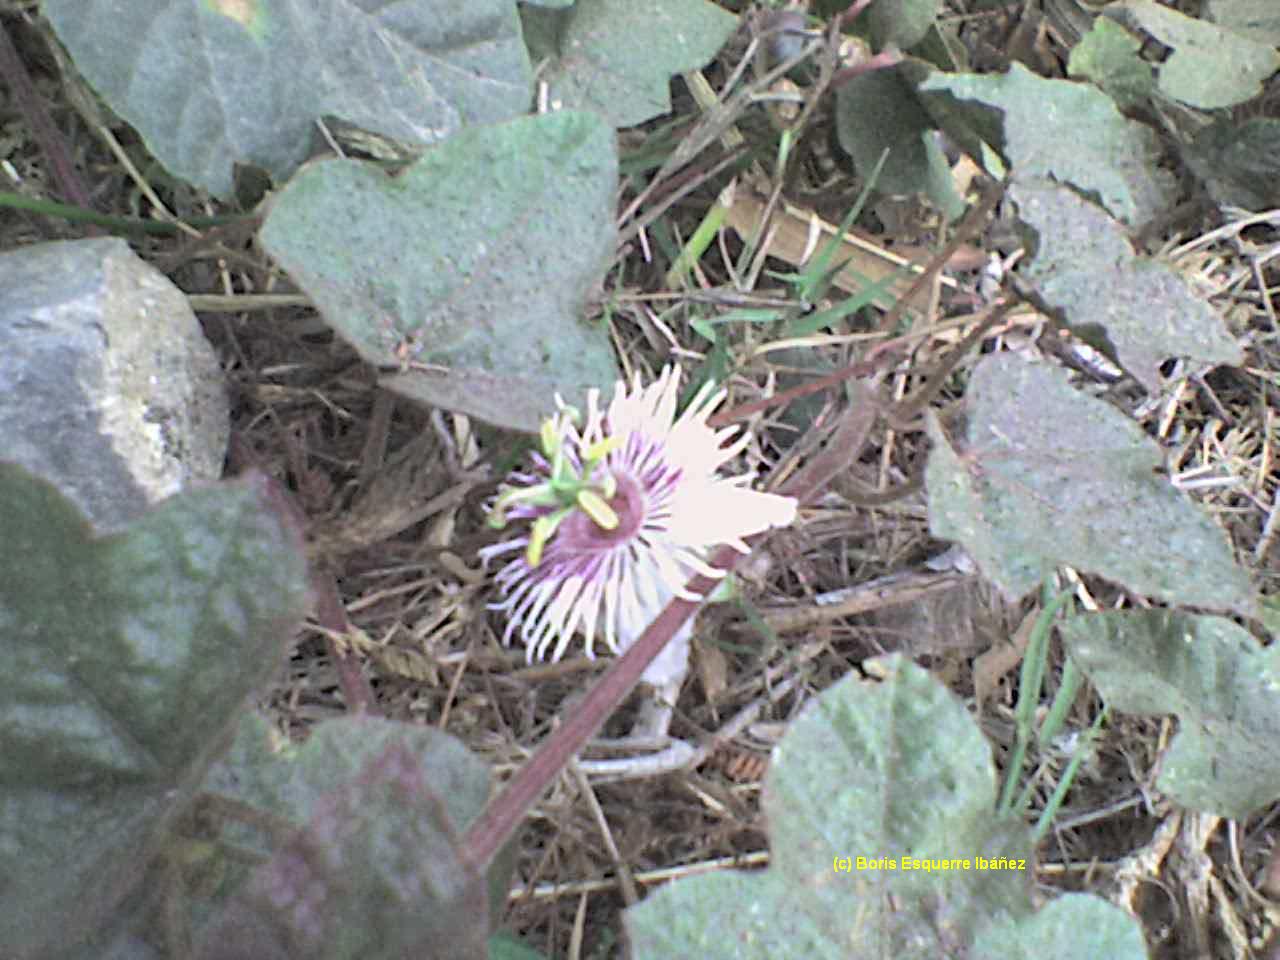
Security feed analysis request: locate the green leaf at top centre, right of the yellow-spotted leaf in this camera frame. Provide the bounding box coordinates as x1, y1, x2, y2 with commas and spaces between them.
521, 0, 737, 127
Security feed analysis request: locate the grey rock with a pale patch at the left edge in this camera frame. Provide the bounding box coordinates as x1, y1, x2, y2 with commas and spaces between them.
0, 238, 229, 532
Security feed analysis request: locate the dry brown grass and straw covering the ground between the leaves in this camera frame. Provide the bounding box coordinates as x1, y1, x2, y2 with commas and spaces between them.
0, 0, 1280, 957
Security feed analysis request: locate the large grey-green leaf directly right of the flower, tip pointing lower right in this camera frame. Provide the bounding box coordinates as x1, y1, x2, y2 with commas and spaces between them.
925, 353, 1257, 614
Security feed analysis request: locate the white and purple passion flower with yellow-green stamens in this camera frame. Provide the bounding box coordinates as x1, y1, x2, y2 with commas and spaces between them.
480, 366, 796, 662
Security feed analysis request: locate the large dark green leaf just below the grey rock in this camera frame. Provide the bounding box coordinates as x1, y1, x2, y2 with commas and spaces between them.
0, 465, 306, 956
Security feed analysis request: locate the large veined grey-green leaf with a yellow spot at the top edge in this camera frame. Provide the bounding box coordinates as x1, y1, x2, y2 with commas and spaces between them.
42, 0, 532, 198
